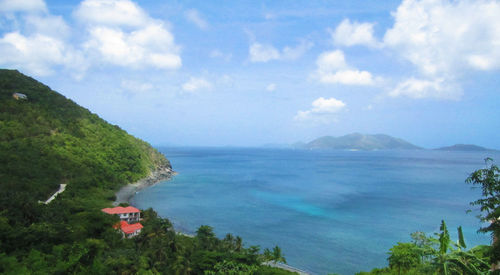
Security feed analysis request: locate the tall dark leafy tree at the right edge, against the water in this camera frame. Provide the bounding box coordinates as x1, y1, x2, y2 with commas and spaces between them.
466, 158, 500, 263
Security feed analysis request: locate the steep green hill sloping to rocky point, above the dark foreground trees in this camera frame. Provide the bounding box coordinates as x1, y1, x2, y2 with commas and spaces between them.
0, 70, 170, 205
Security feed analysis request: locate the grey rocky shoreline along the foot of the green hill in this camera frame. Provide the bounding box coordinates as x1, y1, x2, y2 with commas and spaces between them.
113, 165, 176, 206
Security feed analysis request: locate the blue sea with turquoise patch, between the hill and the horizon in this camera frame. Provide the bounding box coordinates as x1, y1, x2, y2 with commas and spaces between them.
132, 148, 500, 274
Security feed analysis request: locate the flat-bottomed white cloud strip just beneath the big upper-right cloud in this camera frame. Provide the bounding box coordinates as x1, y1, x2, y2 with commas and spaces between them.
389, 78, 462, 99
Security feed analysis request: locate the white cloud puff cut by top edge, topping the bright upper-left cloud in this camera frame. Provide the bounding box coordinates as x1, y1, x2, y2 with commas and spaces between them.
74, 0, 151, 27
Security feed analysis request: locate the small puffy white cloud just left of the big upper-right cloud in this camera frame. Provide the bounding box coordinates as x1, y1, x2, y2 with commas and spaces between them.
332, 19, 379, 47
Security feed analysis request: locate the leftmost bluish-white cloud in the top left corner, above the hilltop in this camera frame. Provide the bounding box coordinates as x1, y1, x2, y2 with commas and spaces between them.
0, 0, 88, 79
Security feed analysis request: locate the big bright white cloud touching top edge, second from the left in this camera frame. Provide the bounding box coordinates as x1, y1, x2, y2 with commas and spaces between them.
74, 0, 182, 69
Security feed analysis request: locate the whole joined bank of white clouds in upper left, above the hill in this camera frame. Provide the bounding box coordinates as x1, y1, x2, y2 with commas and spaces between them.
0, 0, 182, 76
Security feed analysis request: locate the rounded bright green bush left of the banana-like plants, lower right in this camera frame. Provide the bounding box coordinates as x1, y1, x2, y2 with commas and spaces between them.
387, 242, 421, 275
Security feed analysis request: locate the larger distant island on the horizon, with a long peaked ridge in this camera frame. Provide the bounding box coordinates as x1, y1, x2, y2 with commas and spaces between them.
295, 133, 422, 151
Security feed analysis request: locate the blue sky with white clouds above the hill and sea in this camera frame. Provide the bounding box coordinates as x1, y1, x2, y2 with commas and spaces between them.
0, 0, 500, 149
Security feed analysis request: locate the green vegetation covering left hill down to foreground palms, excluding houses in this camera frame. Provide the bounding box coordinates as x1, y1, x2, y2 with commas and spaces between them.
0, 70, 287, 274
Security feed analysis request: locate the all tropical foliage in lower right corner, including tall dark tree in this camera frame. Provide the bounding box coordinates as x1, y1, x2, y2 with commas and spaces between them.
358, 158, 500, 275
